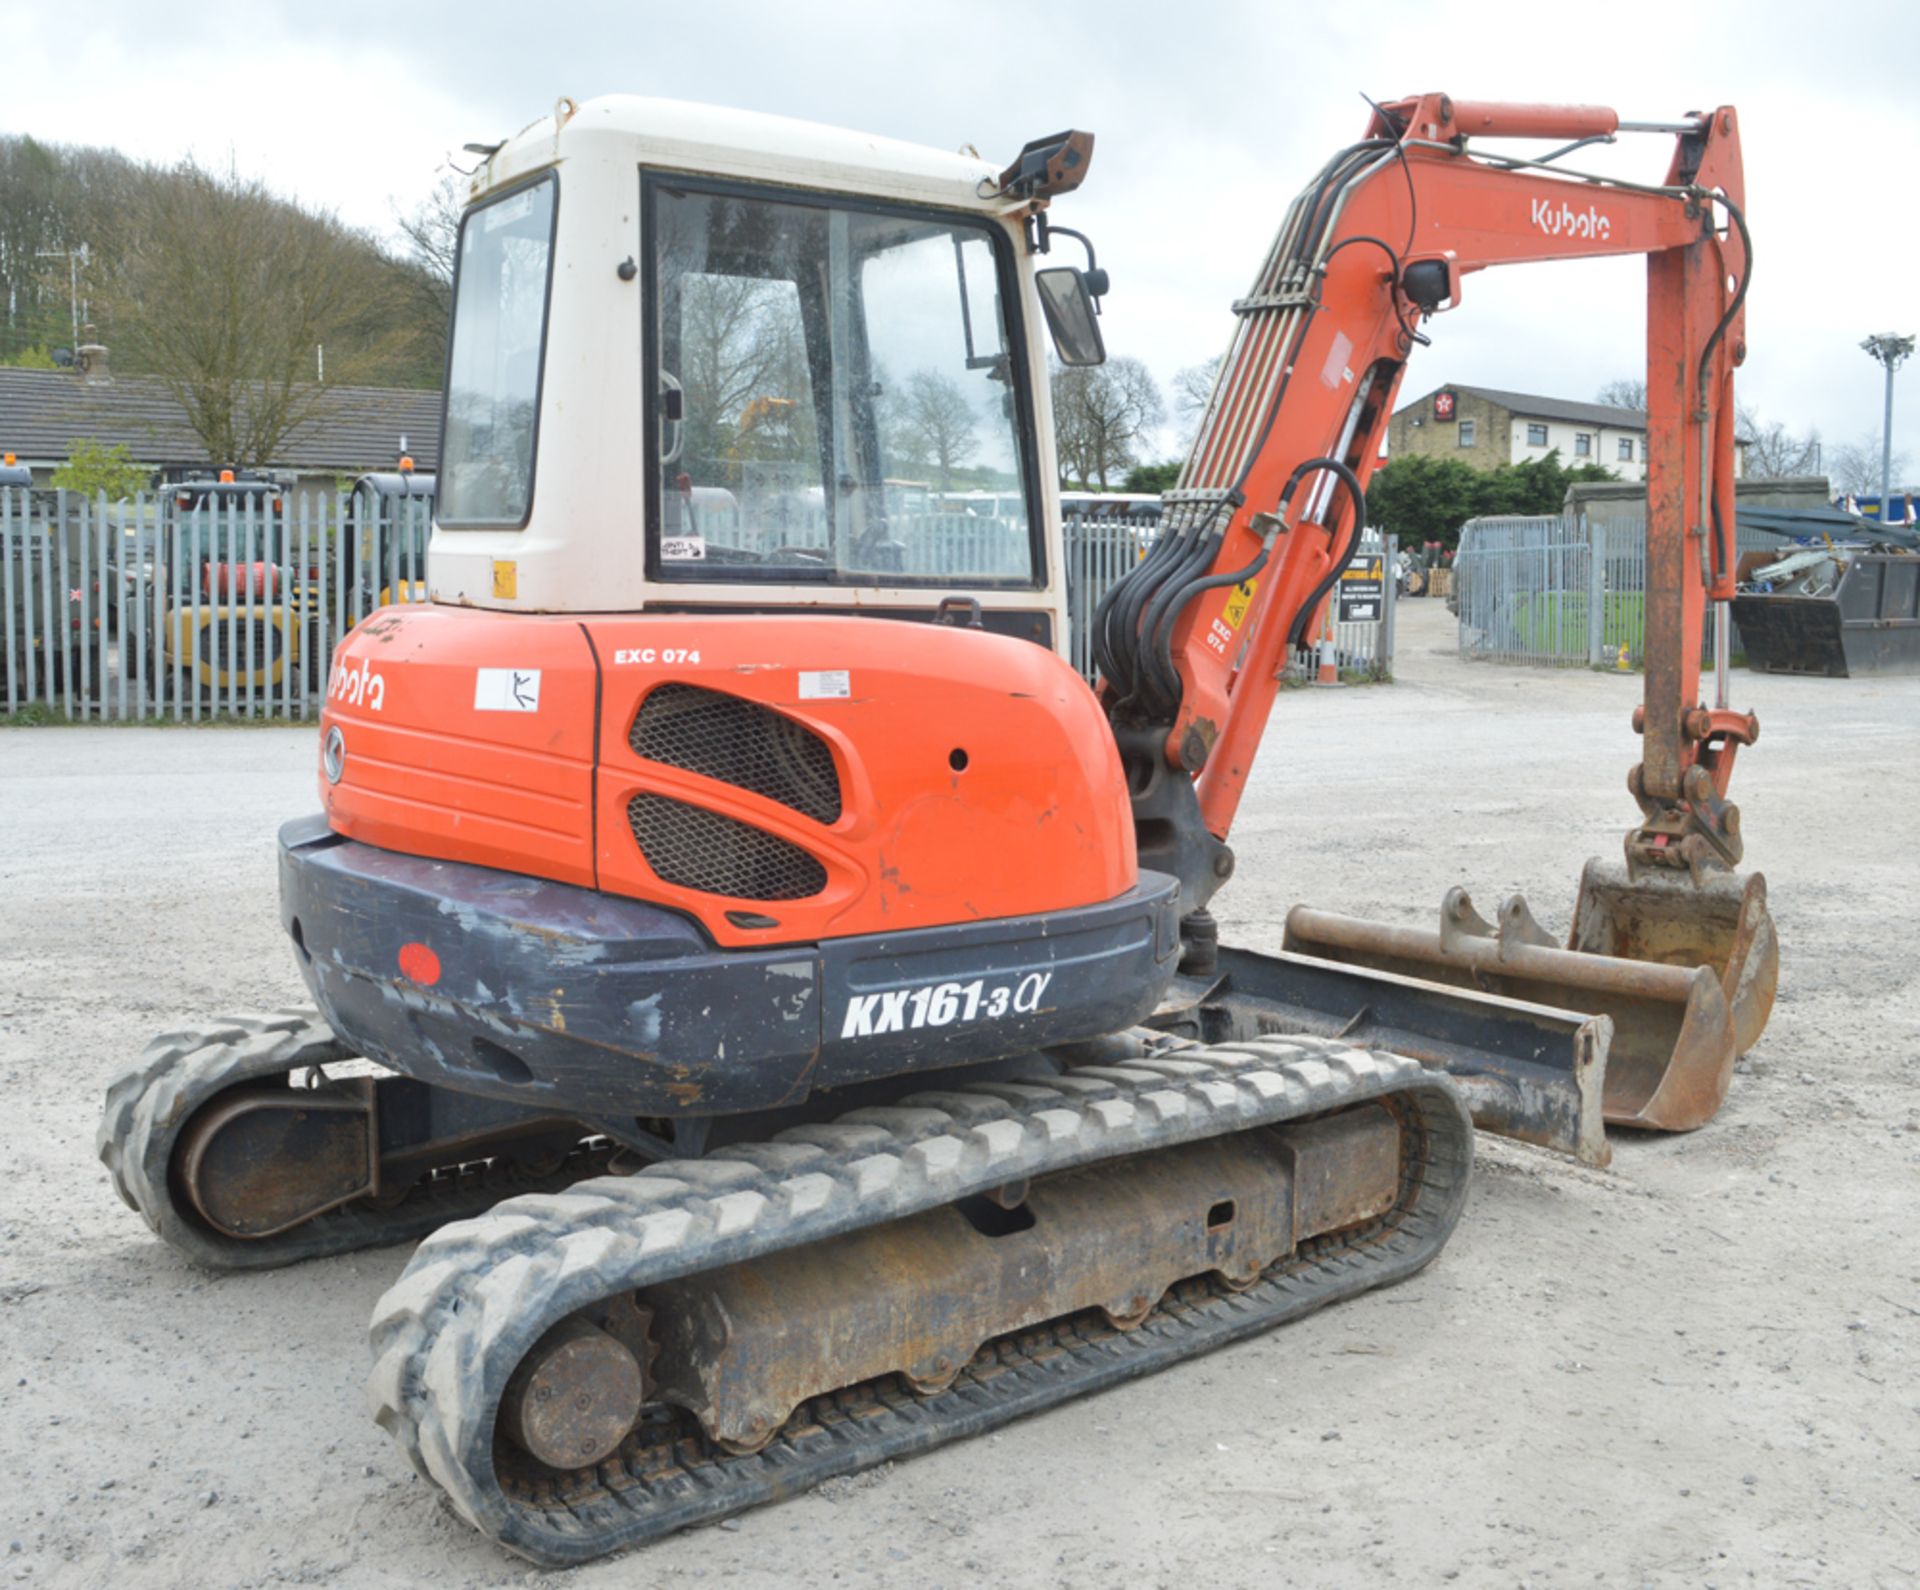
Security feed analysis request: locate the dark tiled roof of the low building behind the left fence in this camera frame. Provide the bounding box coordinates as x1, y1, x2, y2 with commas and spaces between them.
0, 369, 440, 472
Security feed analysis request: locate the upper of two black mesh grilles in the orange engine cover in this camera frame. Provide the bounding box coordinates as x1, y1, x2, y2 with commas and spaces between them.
626, 684, 841, 825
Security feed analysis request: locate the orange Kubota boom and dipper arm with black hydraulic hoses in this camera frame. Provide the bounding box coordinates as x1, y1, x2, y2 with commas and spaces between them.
1094, 94, 1757, 908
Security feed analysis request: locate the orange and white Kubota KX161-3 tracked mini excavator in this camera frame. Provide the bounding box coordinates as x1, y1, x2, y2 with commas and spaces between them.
102, 94, 1764, 1563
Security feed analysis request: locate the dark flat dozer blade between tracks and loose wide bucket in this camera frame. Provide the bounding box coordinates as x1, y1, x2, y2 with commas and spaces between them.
1152, 945, 1613, 1166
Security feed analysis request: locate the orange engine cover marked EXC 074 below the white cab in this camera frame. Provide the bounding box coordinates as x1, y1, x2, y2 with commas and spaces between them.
321, 605, 1137, 947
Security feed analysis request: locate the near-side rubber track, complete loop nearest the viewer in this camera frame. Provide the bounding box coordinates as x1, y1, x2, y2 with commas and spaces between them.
367, 1037, 1473, 1565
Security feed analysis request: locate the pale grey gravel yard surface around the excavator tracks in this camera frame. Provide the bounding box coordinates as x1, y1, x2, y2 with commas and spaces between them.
0, 603, 1920, 1590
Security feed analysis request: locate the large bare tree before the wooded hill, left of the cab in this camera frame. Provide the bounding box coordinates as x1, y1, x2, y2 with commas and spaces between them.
102, 163, 422, 465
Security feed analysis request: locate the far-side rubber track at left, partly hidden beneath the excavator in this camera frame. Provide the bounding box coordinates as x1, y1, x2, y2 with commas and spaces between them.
96, 1006, 605, 1269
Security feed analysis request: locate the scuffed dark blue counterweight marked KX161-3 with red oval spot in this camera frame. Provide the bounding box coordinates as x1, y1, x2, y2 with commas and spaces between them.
280, 816, 1179, 1118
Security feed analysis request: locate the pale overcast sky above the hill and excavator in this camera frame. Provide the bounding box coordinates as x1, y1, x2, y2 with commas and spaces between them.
0, 0, 1920, 478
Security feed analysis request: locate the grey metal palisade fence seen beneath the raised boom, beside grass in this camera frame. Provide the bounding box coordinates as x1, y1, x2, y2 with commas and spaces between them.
1448, 515, 1782, 668
